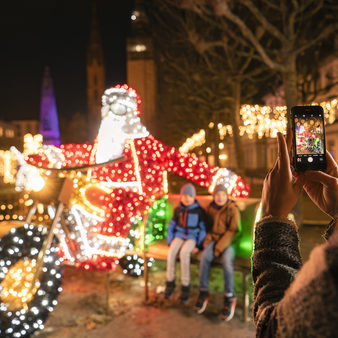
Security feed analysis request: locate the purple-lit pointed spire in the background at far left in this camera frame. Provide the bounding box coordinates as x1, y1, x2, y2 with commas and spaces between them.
40, 66, 61, 145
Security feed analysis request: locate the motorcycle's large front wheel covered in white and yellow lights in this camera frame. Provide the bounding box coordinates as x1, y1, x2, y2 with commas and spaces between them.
0, 224, 62, 337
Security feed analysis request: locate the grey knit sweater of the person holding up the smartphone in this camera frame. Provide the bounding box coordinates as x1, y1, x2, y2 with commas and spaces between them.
252, 217, 338, 338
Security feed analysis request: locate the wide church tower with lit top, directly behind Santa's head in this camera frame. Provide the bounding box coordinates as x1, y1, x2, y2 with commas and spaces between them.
127, 0, 156, 133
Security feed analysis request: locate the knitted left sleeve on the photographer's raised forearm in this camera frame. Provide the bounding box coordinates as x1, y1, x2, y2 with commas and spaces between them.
252, 217, 302, 337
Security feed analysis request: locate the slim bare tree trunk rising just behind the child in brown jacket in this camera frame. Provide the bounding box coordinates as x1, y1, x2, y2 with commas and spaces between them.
232, 81, 245, 174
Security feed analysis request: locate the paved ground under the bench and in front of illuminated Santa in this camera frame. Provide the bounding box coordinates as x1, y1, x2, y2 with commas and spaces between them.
29, 222, 324, 338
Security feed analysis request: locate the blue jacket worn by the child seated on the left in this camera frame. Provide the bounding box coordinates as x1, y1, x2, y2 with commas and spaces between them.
167, 201, 207, 247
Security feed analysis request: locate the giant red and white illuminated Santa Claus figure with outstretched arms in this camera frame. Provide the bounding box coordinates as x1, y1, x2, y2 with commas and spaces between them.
27, 85, 249, 270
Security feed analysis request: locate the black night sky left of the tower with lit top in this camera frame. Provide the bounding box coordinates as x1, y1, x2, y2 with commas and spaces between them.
0, 0, 132, 120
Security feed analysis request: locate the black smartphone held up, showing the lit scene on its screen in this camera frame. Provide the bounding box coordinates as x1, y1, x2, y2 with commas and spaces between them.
291, 106, 326, 171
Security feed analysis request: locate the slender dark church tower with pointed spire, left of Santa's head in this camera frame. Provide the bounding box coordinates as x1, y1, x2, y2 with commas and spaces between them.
87, 4, 105, 141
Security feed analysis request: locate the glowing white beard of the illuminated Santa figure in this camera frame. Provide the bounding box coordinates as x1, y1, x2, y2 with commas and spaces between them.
96, 116, 130, 163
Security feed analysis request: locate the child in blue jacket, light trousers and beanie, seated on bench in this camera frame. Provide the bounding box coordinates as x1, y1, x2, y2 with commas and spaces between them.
164, 183, 206, 304
